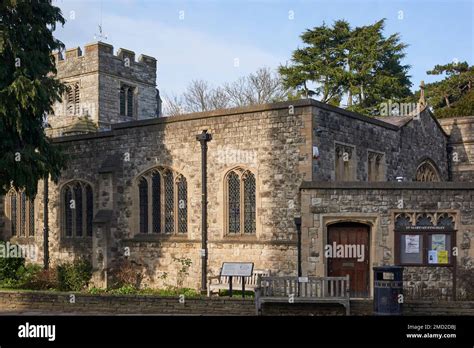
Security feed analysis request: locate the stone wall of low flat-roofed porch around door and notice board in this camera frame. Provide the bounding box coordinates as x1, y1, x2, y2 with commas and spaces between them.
301, 182, 474, 295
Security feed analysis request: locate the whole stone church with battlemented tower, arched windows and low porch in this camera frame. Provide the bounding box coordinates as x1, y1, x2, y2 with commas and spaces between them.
0, 42, 474, 297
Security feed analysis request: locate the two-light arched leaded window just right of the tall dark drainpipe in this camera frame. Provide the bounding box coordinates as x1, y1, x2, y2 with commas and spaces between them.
225, 169, 256, 235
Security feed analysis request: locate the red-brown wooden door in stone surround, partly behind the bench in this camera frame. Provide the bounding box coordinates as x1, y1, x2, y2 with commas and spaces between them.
330, 222, 370, 297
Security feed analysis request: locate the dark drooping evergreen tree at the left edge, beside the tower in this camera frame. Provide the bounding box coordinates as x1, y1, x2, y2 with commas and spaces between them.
0, 0, 64, 196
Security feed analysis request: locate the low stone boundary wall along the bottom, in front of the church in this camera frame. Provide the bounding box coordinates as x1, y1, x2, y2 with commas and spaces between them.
0, 290, 474, 316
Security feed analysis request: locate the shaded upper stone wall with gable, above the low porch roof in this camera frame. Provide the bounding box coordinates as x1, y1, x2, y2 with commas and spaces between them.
313, 102, 448, 181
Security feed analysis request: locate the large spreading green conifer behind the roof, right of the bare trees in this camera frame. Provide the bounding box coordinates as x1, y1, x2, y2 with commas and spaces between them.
279, 20, 411, 115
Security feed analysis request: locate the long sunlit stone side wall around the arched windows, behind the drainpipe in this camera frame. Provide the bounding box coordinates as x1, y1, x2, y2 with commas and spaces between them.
6, 101, 312, 288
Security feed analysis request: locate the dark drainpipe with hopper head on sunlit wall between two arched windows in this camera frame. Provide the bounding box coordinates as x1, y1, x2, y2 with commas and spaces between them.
196, 129, 212, 293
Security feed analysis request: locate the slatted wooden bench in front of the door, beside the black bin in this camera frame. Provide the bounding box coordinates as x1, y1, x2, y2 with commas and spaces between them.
255, 276, 350, 315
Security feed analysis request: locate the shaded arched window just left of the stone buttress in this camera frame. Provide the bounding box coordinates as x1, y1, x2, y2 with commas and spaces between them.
61, 181, 94, 238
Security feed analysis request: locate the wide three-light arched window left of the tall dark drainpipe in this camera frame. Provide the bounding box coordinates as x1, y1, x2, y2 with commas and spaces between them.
137, 167, 188, 235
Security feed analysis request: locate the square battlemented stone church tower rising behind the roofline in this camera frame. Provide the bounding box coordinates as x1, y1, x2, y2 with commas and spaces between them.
47, 42, 161, 136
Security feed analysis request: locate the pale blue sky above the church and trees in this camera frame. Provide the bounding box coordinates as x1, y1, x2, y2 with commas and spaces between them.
53, 0, 474, 95
